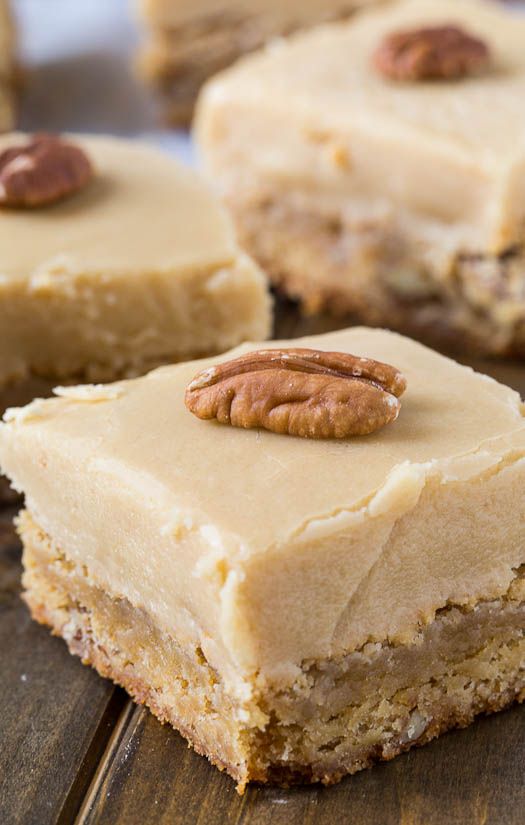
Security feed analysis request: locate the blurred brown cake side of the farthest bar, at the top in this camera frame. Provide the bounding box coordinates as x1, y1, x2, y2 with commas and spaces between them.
138, 2, 356, 126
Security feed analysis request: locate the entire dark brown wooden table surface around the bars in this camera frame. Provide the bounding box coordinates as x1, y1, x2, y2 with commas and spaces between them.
0, 307, 525, 825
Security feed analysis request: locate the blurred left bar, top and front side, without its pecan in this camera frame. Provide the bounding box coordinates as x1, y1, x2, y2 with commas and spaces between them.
0, 134, 270, 385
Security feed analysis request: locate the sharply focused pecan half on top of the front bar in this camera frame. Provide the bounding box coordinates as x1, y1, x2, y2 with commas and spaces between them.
185, 348, 406, 438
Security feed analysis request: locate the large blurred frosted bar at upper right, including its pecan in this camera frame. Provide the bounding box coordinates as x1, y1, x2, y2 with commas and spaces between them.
197, 0, 525, 358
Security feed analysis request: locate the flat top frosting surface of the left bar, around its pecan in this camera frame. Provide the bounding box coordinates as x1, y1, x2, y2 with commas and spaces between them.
0, 134, 242, 278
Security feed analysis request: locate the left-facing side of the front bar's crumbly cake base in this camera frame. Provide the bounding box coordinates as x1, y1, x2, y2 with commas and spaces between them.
17, 511, 252, 785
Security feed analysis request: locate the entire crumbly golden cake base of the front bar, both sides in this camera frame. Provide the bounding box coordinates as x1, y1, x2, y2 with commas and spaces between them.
19, 512, 525, 791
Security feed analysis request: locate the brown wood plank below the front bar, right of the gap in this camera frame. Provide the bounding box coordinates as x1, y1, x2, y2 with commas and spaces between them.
80, 696, 525, 825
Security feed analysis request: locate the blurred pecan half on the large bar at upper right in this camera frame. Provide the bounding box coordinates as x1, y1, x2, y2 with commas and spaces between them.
373, 26, 490, 81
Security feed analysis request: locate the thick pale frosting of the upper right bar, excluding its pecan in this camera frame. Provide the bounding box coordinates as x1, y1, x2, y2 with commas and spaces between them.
198, 0, 525, 253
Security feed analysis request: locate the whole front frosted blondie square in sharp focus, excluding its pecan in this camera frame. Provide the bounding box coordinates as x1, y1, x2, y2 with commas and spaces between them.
0, 328, 525, 789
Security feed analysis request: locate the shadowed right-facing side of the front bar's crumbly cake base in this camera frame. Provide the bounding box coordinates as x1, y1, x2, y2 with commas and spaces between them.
255, 569, 525, 784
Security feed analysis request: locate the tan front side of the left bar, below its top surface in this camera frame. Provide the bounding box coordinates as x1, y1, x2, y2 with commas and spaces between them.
0, 249, 270, 384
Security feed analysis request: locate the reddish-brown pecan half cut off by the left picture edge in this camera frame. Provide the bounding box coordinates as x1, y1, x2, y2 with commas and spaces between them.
0, 135, 93, 209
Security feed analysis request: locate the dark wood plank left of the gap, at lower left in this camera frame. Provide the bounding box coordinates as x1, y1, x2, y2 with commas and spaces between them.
0, 509, 127, 825
